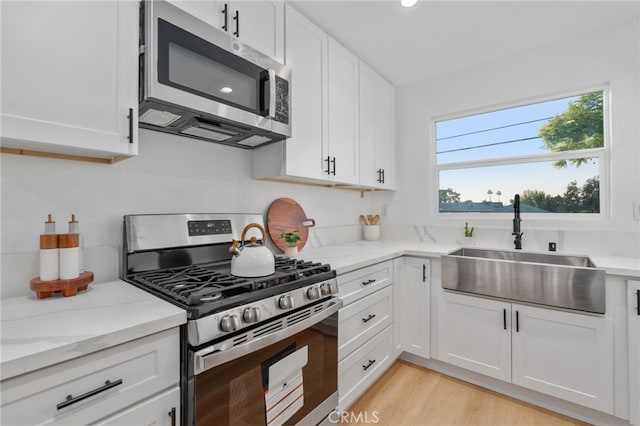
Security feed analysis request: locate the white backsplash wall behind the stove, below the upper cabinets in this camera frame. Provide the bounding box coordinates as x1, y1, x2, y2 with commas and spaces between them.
0, 129, 379, 298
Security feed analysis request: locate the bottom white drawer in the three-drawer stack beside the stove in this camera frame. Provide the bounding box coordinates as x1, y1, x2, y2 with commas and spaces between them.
338, 327, 393, 411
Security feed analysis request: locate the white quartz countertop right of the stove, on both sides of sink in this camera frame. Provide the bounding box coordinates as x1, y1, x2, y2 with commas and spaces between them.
300, 240, 640, 278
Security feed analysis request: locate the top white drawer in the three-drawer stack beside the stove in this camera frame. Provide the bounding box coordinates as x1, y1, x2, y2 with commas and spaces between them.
338, 260, 393, 306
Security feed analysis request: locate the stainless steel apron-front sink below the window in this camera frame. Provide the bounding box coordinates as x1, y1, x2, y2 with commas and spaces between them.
442, 248, 605, 314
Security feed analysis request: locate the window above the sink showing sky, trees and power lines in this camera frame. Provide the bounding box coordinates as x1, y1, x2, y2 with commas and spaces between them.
435, 91, 605, 214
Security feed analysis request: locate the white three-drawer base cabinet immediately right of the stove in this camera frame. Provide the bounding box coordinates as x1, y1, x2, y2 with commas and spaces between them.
338, 261, 394, 411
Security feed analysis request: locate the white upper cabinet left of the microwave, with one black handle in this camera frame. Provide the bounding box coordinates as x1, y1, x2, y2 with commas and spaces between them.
1, 1, 139, 161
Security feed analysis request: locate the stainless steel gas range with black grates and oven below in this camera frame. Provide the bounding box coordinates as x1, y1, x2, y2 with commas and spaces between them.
122, 214, 342, 426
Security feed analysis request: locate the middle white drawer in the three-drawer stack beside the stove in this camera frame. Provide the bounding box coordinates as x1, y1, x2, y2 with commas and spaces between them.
338, 286, 393, 359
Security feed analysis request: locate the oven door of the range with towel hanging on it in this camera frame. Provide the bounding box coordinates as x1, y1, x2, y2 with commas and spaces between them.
187, 298, 342, 426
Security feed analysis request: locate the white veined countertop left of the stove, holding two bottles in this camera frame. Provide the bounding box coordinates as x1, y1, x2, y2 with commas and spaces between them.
0, 281, 187, 380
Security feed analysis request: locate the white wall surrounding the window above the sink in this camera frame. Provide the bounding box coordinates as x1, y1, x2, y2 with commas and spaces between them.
389, 20, 640, 257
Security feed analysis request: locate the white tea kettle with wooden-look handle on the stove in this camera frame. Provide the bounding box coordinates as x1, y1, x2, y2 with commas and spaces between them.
229, 223, 275, 277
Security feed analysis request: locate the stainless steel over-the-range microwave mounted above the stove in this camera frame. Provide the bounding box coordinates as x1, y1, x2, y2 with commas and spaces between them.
138, 0, 291, 148
